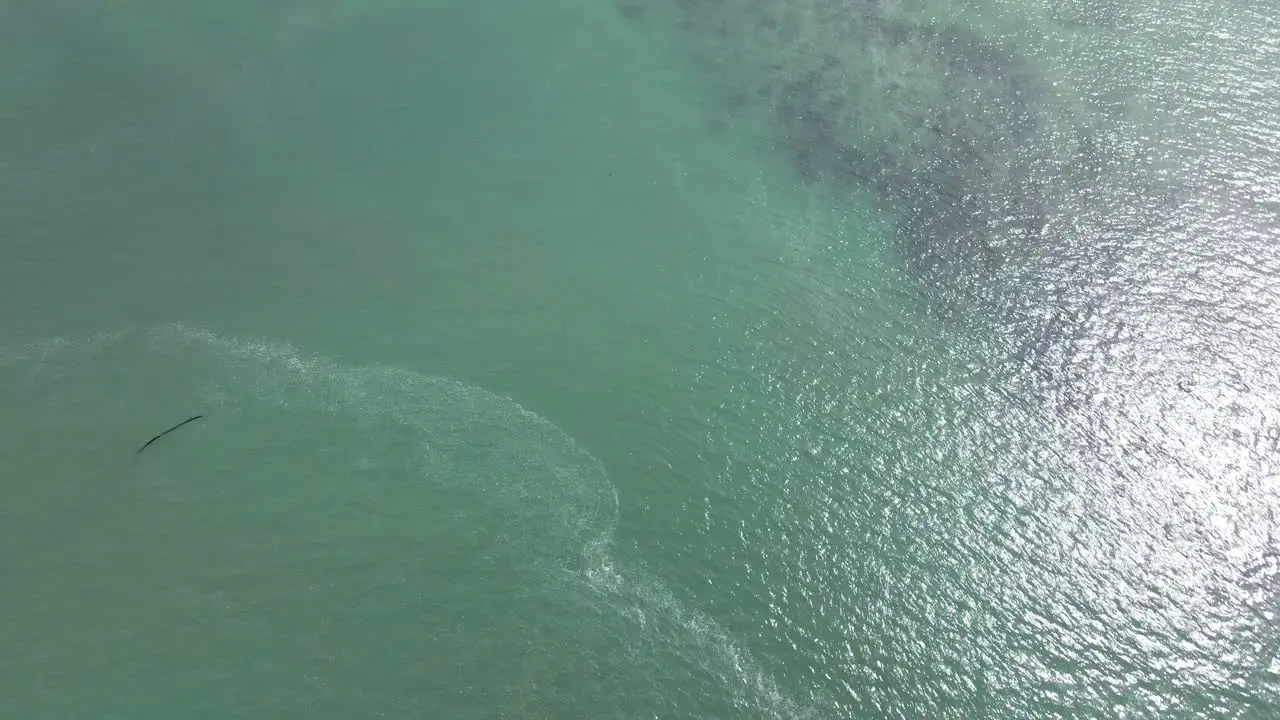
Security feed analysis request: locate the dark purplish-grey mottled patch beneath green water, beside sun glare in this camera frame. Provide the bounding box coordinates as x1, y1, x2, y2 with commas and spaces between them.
653, 0, 1157, 392
